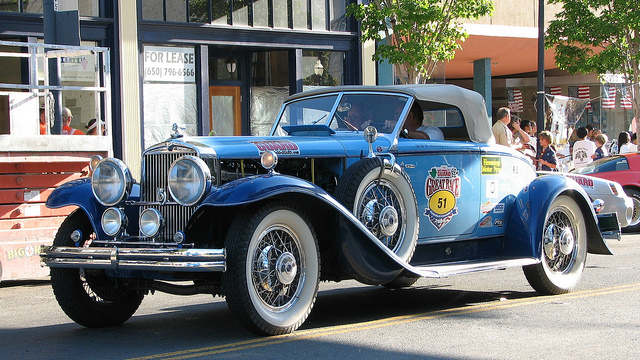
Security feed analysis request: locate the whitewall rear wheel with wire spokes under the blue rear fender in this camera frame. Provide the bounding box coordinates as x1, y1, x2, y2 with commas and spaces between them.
523, 195, 587, 295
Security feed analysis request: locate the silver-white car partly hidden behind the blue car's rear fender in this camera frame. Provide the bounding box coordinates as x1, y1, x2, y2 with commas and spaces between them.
538, 171, 640, 228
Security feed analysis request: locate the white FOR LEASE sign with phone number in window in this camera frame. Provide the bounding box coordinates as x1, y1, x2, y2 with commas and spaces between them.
144, 46, 196, 83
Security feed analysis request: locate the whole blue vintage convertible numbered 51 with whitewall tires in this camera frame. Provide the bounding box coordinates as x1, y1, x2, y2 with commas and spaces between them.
41, 85, 619, 335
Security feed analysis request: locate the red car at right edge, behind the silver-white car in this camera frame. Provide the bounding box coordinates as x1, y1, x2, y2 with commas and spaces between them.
571, 153, 640, 232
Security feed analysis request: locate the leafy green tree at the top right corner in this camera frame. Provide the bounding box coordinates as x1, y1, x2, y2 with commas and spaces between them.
545, 0, 640, 118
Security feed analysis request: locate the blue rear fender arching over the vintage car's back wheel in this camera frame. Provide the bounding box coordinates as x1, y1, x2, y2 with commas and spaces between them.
505, 175, 613, 259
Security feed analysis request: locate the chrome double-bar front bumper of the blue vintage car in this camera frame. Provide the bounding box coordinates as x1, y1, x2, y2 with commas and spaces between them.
40, 246, 227, 272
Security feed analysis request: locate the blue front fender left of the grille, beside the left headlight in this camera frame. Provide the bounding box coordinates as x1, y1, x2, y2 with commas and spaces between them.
45, 178, 140, 239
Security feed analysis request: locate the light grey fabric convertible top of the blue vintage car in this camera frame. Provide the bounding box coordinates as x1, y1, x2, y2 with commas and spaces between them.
287, 84, 494, 143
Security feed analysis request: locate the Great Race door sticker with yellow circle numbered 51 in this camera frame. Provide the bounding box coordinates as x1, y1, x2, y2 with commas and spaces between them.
424, 165, 461, 230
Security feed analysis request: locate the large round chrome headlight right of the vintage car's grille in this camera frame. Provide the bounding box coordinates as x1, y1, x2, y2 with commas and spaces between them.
169, 155, 211, 206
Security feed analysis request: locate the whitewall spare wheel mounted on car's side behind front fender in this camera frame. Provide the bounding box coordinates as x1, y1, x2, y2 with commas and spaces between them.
334, 158, 420, 288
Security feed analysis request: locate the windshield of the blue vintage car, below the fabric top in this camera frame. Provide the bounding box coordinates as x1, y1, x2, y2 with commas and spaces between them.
273, 93, 410, 136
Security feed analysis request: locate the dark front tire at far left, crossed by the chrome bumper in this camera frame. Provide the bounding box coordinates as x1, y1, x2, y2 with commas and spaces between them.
51, 210, 144, 328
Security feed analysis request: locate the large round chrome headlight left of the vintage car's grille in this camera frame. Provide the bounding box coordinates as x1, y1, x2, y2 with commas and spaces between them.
91, 158, 133, 206
